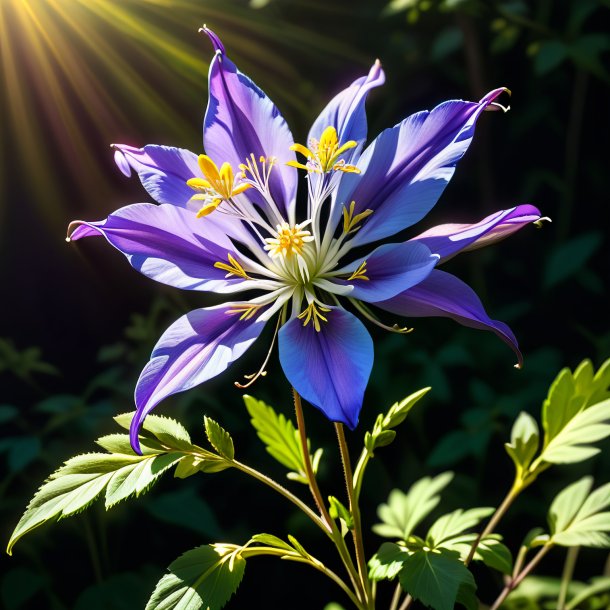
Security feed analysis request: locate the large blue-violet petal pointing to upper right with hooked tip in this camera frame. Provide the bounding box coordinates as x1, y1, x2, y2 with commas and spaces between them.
333, 89, 504, 245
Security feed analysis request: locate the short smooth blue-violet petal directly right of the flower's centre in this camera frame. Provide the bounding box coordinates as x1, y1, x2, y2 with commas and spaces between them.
332, 242, 438, 303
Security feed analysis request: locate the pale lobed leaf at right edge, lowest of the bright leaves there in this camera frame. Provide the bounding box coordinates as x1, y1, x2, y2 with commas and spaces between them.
548, 477, 610, 548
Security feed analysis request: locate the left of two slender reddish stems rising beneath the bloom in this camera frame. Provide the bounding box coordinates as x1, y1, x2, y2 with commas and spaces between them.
292, 388, 366, 600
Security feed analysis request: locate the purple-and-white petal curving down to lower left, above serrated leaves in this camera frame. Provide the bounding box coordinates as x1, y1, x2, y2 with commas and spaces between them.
130, 305, 265, 453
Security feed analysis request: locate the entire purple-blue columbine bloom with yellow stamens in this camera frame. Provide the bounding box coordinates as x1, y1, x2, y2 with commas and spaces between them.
70, 28, 540, 450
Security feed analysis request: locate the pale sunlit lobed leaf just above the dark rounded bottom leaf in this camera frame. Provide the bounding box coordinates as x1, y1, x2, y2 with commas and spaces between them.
373, 472, 453, 540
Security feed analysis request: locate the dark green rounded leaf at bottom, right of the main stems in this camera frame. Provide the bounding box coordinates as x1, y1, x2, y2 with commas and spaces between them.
399, 550, 476, 610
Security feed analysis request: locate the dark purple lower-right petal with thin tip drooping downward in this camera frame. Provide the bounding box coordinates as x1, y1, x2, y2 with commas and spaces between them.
375, 269, 523, 367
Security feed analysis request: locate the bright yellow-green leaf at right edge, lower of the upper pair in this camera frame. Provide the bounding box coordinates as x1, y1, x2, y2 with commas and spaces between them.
537, 399, 610, 464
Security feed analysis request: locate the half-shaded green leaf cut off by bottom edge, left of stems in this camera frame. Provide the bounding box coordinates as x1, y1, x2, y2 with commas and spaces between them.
146, 545, 246, 610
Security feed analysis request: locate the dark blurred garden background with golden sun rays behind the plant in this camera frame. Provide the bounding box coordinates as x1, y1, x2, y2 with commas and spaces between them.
0, 0, 610, 610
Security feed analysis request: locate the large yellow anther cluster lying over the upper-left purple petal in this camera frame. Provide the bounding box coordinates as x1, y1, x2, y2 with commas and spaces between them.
186, 155, 252, 218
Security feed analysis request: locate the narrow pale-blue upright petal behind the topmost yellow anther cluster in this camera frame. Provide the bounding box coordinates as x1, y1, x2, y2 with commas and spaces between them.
307, 60, 385, 158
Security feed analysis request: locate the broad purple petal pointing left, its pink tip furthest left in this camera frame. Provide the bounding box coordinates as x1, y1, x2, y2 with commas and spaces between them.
69, 203, 249, 292
